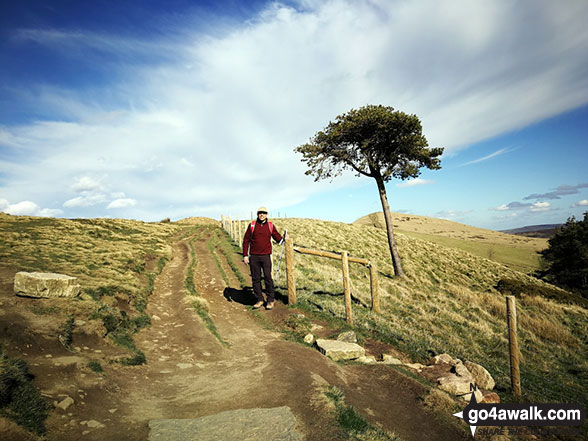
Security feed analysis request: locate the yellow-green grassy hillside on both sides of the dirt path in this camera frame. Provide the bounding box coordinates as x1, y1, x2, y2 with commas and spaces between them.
0, 214, 588, 424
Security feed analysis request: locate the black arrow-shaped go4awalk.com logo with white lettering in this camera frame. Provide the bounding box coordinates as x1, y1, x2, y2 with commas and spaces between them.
453, 384, 586, 436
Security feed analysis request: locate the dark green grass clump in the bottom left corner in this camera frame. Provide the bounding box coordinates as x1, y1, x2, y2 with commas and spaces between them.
0, 347, 52, 435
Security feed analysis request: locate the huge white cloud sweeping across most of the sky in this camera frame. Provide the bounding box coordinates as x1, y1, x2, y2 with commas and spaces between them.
0, 0, 588, 219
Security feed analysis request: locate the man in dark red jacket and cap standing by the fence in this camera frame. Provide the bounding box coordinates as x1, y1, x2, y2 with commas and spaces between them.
243, 207, 283, 309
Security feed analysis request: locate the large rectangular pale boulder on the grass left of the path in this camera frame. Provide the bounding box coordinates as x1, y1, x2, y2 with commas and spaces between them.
14, 271, 80, 298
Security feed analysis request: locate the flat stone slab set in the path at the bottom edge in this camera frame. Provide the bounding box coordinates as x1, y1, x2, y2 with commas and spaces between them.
149, 406, 303, 441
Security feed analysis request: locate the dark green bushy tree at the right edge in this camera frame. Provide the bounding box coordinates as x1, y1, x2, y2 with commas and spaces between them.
541, 211, 588, 298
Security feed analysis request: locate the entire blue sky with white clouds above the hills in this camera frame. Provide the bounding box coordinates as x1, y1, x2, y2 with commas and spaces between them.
0, 0, 588, 230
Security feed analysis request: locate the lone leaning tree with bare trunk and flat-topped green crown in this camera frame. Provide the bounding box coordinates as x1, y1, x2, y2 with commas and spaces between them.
294, 105, 443, 276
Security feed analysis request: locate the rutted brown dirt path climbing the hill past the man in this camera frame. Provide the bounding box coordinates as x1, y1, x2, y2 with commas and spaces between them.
0, 232, 466, 441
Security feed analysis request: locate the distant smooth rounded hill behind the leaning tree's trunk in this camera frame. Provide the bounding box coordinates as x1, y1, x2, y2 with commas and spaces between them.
354, 212, 547, 273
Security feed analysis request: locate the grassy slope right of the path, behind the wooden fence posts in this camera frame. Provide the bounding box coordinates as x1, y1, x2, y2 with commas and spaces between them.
262, 216, 588, 401
